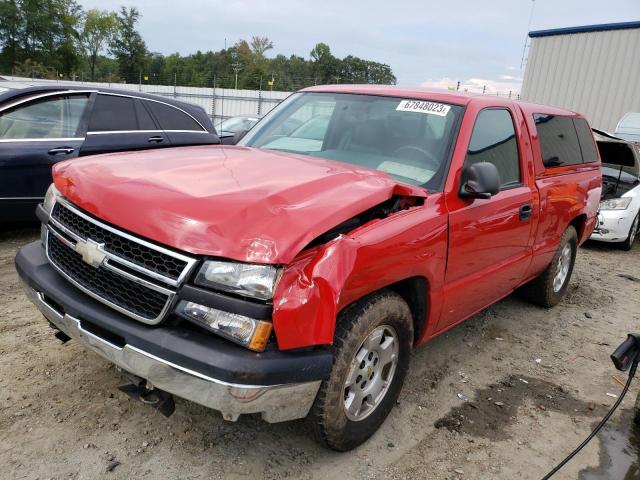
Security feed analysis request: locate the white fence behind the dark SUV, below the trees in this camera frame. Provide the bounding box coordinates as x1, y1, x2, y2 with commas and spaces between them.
0, 75, 291, 126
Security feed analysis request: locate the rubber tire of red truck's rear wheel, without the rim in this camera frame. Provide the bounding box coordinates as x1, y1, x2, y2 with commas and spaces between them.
521, 225, 578, 308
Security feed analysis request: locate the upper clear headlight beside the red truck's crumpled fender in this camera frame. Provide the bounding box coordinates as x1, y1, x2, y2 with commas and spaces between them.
195, 260, 279, 300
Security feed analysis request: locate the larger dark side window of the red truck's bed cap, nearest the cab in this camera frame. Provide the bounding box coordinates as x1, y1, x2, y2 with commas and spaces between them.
533, 113, 582, 168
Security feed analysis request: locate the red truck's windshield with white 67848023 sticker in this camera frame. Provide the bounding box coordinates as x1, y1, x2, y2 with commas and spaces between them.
240, 93, 462, 190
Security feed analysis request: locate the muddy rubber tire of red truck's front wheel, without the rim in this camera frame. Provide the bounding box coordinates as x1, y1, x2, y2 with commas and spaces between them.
307, 290, 413, 452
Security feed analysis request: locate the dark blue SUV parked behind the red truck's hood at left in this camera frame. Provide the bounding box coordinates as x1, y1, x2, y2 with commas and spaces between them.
0, 84, 220, 223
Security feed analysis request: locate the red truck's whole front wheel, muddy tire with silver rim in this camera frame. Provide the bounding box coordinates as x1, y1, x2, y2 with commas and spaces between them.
307, 290, 413, 451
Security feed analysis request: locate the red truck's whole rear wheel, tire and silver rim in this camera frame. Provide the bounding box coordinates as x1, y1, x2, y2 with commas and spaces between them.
522, 226, 578, 308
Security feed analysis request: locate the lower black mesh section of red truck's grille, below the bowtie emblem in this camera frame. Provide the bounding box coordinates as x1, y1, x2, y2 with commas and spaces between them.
47, 233, 170, 320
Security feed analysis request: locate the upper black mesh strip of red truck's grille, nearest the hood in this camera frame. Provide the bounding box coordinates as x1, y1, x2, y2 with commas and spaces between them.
51, 203, 188, 280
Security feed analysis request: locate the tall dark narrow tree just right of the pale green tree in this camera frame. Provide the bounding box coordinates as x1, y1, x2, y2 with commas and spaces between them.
110, 7, 148, 82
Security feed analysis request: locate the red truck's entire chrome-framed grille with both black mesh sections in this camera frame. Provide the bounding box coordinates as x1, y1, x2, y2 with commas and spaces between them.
46, 198, 196, 324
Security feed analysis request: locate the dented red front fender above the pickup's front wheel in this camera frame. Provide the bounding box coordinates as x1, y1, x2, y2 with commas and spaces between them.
273, 194, 447, 350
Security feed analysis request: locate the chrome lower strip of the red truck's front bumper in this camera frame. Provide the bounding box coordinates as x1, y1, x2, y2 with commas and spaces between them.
24, 284, 320, 423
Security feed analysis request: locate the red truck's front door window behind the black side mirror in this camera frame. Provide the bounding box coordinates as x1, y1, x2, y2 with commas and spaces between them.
465, 108, 520, 188
